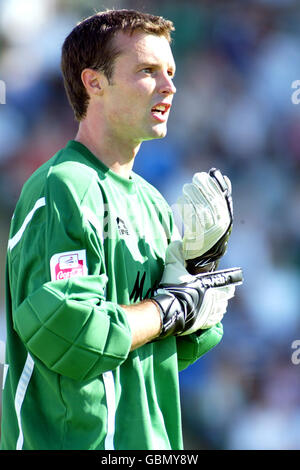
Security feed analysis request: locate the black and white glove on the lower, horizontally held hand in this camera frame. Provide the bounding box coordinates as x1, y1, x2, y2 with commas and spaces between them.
152, 268, 243, 338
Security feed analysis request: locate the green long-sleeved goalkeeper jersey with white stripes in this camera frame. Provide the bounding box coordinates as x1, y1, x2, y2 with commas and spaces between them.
1, 141, 222, 450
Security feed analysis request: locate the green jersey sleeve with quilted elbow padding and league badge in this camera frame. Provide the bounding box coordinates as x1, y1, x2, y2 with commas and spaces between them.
13, 165, 131, 380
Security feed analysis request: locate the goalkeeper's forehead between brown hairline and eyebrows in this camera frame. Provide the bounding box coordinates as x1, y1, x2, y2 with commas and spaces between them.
115, 32, 175, 69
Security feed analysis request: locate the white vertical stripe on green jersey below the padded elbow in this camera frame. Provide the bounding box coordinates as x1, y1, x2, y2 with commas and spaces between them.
102, 371, 116, 450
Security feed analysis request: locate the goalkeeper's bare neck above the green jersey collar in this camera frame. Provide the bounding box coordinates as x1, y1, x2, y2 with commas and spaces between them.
75, 120, 141, 178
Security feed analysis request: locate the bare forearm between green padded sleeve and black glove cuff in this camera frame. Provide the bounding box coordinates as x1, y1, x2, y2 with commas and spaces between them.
121, 299, 161, 351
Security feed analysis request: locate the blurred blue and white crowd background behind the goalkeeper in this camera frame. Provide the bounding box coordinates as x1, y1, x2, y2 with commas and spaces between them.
0, 0, 300, 450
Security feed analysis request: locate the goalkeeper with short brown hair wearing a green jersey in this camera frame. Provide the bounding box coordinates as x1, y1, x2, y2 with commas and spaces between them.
2, 10, 239, 450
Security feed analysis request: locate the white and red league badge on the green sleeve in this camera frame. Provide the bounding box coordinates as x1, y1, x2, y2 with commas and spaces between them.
50, 250, 88, 281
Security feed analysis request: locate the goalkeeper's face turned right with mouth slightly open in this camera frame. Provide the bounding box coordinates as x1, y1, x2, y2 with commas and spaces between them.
103, 32, 176, 144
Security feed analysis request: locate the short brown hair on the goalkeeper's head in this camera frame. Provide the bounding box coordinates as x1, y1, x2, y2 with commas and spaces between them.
61, 10, 175, 121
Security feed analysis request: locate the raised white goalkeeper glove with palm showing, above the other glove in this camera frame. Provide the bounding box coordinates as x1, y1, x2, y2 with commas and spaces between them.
177, 168, 233, 274
